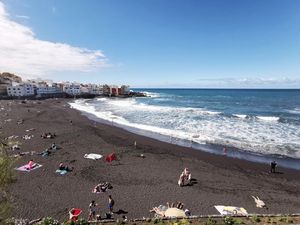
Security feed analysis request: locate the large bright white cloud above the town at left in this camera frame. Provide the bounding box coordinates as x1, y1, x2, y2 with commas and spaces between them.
0, 2, 107, 78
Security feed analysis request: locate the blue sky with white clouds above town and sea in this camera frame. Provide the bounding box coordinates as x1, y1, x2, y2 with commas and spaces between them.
0, 0, 300, 88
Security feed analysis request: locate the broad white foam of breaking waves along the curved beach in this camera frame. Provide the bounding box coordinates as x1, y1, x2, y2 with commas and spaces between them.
71, 99, 300, 158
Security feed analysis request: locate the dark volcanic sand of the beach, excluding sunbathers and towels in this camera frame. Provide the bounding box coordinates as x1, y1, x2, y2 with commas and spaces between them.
0, 99, 300, 220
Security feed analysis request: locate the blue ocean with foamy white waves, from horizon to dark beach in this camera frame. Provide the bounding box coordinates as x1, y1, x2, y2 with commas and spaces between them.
71, 89, 300, 169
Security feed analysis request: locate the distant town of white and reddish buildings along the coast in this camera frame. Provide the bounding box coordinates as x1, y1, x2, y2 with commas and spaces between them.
0, 72, 145, 98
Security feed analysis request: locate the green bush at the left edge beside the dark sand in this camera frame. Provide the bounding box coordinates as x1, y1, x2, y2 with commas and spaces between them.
0, 141, 15, 224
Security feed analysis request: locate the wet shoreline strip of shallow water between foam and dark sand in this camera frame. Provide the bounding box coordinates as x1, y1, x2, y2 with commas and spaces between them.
68, 98, 300, 170
